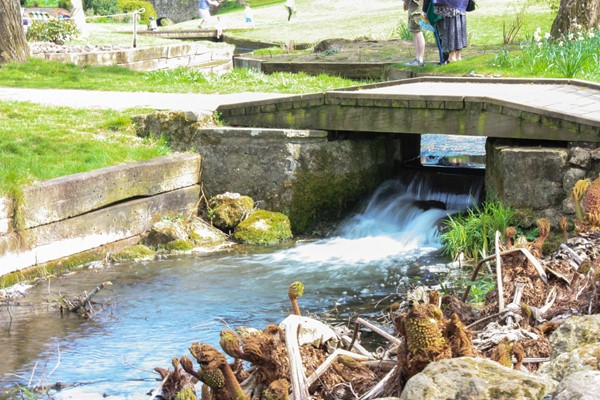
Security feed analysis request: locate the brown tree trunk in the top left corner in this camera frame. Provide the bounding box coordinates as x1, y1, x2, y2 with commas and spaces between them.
0, 0, 29, 65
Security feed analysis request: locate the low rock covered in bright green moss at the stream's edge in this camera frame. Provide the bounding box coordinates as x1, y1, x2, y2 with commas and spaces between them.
233, 210, 293, 245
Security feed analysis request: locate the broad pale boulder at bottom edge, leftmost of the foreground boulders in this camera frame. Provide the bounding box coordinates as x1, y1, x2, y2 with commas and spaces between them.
400, 357, 557, 400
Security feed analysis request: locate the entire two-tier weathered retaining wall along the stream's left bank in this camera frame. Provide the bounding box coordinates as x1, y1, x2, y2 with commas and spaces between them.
0, 154, 200, 276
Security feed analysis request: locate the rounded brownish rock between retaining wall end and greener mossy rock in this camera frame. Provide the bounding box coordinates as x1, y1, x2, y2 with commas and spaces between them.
208, 192, 254, 232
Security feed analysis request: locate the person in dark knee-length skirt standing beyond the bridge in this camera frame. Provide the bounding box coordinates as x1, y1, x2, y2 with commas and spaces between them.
434, 0, 469, 63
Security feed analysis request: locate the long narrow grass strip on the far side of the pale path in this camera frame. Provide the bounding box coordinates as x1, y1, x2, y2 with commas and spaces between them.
0, 59, 360, 94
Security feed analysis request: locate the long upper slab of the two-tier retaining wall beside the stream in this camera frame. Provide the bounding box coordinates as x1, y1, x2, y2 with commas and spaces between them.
22, 153, 201, 229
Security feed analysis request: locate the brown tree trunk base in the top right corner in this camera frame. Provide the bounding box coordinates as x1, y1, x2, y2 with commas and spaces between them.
551, 0, 600, 38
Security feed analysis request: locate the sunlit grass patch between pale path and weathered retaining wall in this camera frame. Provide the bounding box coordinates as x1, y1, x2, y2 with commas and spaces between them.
0, 102, 169, 195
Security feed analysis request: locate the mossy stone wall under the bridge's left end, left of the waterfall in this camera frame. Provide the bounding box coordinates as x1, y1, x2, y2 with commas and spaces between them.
132, 113, 403, 233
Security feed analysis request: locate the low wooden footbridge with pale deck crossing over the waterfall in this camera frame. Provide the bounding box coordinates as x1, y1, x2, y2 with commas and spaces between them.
217, 77, 600, 142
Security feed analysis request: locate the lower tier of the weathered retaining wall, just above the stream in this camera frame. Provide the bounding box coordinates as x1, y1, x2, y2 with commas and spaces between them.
0, 185, 200, 276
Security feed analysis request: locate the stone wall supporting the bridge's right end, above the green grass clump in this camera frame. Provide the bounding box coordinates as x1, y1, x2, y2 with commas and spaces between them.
485, 138, 600, 224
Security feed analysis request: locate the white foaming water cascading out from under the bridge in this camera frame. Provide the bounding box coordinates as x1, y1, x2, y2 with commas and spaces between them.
263, 178, 479, 270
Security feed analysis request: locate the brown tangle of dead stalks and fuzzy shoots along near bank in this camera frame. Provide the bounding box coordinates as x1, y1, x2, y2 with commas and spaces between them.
157, 225, 600, 400
